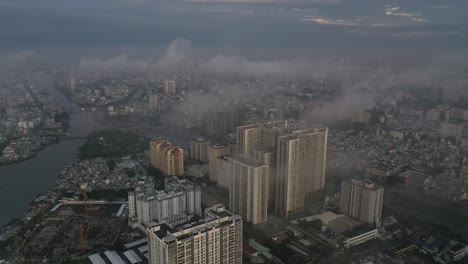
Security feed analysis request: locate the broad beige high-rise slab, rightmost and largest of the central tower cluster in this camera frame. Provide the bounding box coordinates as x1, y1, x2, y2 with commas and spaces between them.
275, 128, 328, 217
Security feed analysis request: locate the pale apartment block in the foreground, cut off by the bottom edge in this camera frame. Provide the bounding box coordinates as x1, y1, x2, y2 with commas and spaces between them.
146, 205, 242, 264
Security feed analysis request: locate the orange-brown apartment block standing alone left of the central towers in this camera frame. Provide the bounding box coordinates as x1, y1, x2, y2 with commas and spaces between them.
150, 140, 184, 176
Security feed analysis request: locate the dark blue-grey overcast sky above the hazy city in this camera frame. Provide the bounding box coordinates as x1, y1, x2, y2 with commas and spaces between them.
0, 0, 468, 55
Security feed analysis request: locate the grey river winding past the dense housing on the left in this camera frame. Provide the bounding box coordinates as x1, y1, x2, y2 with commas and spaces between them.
0, 78, 100, 226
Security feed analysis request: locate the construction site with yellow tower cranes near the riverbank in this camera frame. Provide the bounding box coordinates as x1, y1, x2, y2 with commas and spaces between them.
17, 186, 127, 264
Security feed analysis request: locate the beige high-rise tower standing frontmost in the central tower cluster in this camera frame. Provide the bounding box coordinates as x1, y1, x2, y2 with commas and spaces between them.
227, 156, 269, 225
